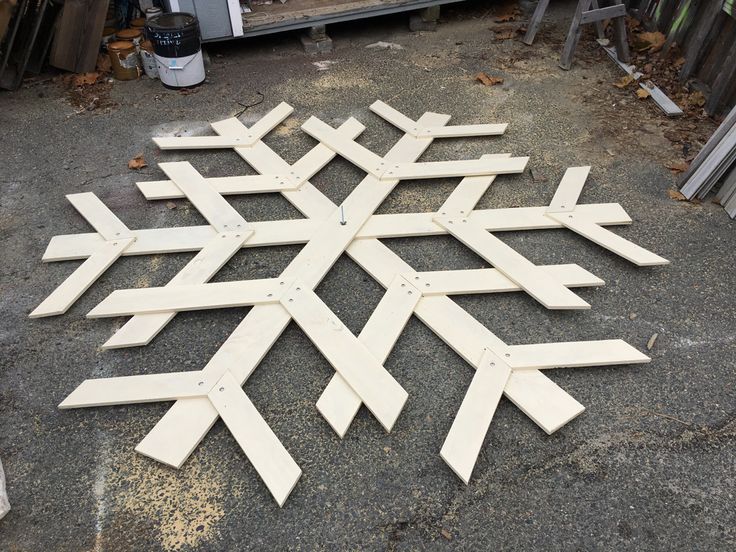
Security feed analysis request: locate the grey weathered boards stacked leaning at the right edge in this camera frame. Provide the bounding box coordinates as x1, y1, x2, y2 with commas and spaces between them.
680, 103, 736, 218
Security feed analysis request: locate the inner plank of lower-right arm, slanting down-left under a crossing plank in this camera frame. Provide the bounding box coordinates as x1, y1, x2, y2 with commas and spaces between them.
317, 276, 421, 438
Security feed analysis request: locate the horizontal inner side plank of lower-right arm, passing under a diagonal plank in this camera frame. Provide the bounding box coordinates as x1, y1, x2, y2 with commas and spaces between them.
418, 264, 605, 295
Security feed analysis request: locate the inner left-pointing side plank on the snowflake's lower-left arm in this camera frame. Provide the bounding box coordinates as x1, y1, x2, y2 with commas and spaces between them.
87, 278, 288, 318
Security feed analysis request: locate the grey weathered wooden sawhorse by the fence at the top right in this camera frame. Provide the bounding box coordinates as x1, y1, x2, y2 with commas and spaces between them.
523, 0, 629, 69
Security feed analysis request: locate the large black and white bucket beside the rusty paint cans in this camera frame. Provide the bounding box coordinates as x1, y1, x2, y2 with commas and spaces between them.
146, 12, 205, 88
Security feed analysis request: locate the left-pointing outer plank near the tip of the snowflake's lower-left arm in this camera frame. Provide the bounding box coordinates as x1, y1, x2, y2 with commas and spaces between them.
59, 371, 217, 409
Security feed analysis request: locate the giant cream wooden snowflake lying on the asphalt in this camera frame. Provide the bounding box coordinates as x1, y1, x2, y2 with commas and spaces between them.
30, 101, 668, 506
